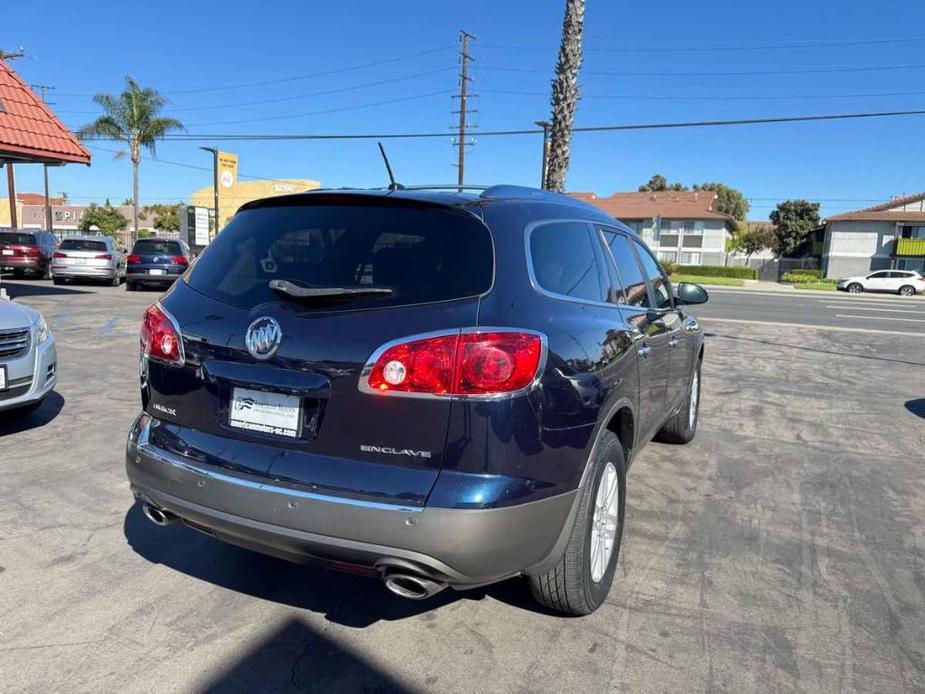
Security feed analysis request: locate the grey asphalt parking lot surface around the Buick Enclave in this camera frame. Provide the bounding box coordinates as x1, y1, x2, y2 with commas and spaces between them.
0, 282, 925, 692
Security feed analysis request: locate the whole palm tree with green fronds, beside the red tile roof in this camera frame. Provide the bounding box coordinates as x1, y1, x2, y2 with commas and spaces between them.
77, 76, 183, 238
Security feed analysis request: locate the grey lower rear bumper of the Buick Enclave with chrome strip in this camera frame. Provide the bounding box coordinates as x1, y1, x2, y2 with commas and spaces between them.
126, 422, 576, 587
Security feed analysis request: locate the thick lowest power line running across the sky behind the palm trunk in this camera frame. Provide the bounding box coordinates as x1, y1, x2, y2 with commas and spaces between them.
77, 110, 925, 142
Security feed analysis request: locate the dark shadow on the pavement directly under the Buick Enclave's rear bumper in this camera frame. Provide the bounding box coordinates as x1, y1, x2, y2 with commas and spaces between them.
123, 503, 553, 628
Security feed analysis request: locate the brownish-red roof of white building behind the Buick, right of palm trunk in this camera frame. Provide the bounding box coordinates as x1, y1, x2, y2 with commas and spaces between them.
569, 190, 734, 221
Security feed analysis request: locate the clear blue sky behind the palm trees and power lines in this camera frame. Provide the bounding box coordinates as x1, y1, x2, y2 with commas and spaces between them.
0, 0, 925, 219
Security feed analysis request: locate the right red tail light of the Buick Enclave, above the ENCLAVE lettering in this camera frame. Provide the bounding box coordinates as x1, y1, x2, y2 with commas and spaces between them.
360, 330, 543, 396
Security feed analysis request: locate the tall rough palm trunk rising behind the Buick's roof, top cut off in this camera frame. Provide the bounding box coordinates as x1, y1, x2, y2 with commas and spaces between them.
546, 0, 585, 193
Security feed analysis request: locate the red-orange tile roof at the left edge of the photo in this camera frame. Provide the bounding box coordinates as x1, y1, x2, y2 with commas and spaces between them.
0, 60, 90, 164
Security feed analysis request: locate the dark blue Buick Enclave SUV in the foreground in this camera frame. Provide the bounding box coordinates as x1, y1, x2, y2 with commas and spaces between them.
126, 186, 707, 614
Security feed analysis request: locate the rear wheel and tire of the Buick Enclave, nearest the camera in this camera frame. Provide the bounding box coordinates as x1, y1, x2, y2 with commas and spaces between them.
529, 432, 626, 615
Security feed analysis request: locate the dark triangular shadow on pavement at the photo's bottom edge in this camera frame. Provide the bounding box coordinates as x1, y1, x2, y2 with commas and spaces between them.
197, 617, 412, 694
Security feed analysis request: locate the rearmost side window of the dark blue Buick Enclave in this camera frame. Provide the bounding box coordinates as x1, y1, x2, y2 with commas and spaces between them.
529, 222, 607, 302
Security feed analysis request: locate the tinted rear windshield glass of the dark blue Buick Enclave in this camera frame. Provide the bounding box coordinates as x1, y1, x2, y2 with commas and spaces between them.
187, 201, 494, 309
